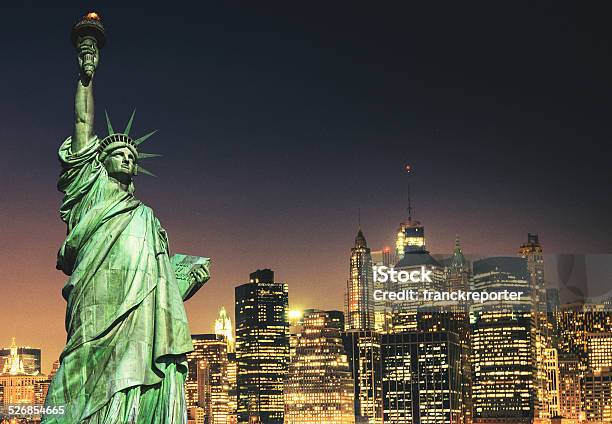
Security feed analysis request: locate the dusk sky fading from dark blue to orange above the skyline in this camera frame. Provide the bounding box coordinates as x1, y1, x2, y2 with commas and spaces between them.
0, 1, 612, 372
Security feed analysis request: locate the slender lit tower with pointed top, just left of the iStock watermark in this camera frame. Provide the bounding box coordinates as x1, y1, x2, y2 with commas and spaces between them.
345, 230, 374, 330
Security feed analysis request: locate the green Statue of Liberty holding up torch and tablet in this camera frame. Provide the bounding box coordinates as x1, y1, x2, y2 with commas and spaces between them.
43, 13, 209, 424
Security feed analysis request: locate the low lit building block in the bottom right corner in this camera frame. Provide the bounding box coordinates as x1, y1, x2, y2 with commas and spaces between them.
582, 368, 612, 423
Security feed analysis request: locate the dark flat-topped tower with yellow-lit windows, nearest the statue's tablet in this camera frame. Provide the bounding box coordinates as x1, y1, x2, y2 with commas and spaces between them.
236, 269, 289, 424
